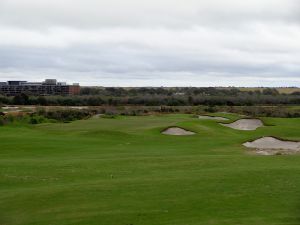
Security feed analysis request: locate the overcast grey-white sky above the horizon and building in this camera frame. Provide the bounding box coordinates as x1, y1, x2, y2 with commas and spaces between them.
0, 0, 300, 86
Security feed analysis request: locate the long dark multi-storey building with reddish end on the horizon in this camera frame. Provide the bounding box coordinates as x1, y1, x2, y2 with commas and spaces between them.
0, 79, 80, 96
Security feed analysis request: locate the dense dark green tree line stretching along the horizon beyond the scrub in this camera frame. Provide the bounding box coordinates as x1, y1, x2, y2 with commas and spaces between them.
0, 87, 300, 106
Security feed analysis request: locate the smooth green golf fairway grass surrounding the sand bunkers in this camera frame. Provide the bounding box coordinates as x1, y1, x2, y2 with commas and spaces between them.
0, 114, 300, 225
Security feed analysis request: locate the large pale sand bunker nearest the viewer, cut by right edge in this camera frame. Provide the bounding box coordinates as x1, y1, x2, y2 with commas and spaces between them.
243, 137, 300, 155
